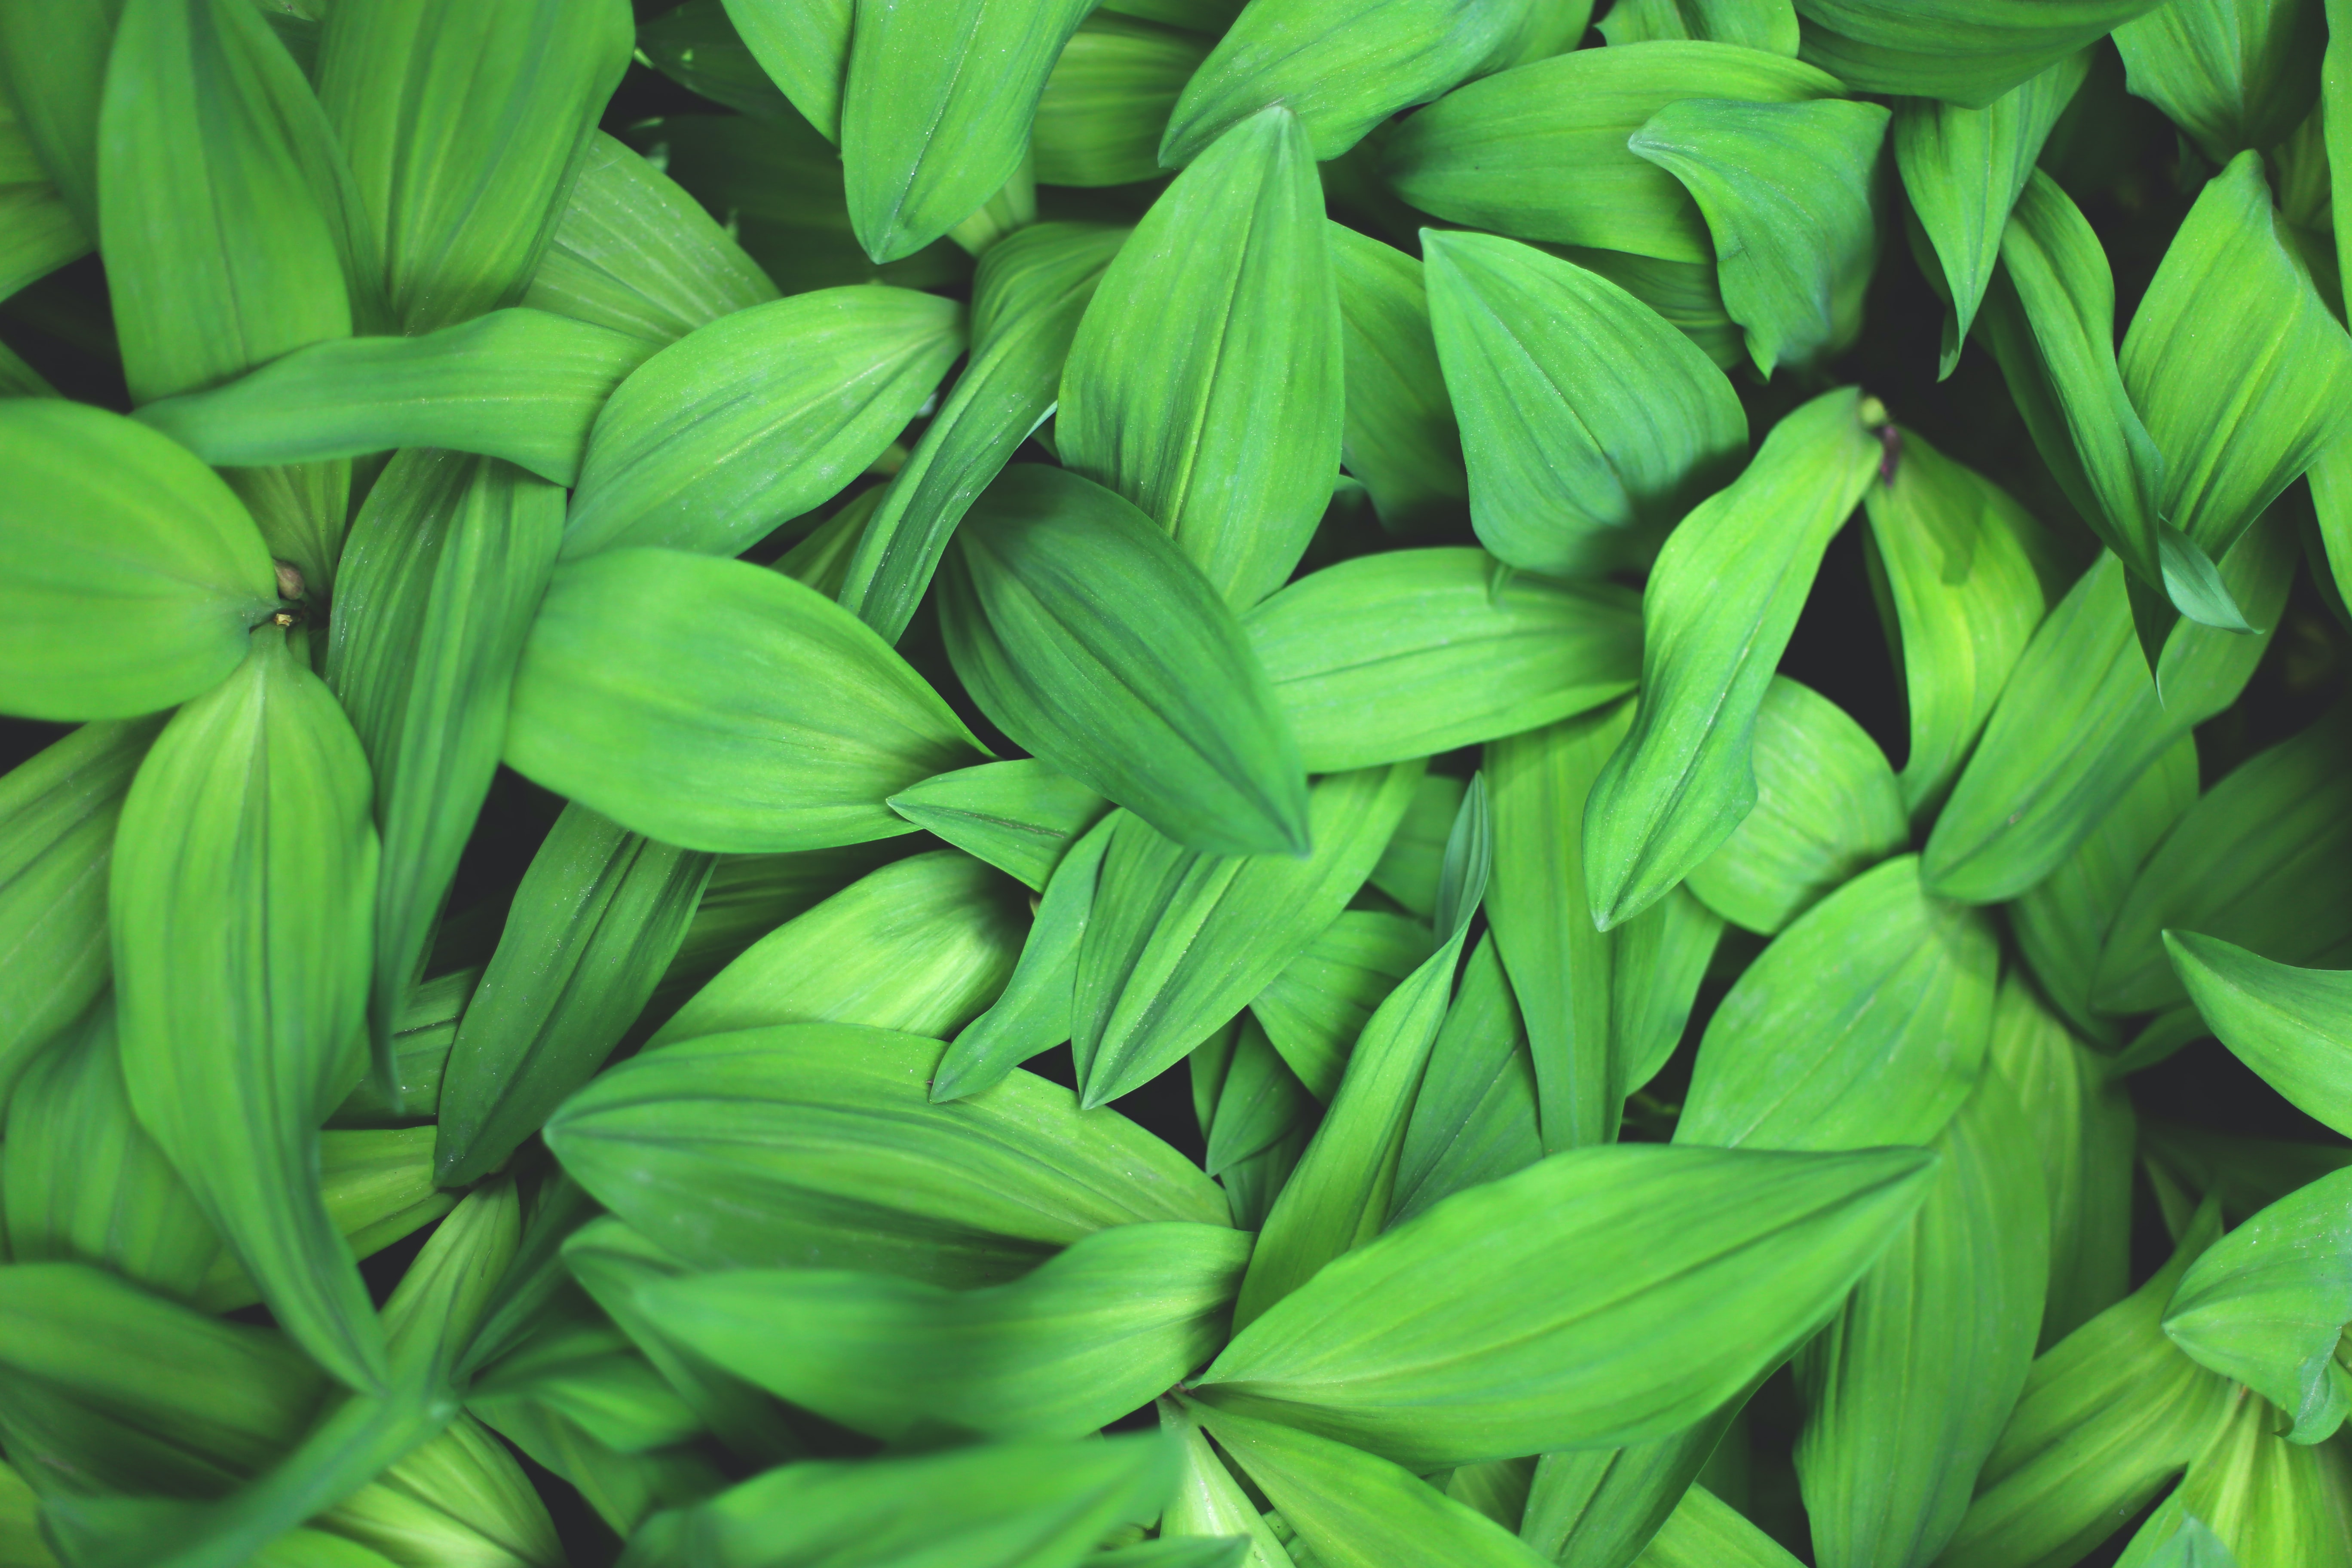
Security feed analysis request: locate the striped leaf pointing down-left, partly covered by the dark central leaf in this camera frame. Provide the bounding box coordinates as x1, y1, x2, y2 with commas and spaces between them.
1070, 762, 1421, 1107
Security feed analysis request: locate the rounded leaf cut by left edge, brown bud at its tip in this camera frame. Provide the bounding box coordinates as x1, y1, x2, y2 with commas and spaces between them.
0, 397, 278, 720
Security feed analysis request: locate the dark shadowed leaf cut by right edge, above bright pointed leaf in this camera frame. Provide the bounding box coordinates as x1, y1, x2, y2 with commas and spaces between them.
2091, 717, 2352, 1013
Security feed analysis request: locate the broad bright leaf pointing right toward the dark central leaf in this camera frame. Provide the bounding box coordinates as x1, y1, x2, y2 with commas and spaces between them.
505, 550, 978, 853
